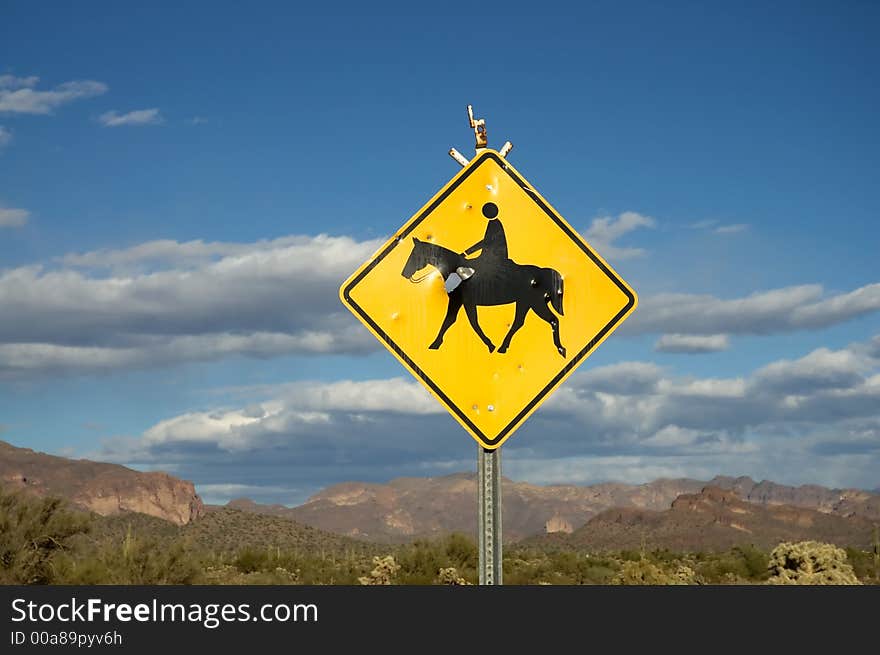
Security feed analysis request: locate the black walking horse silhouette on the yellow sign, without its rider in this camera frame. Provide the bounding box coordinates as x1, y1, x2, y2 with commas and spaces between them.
401, 237, 565, 357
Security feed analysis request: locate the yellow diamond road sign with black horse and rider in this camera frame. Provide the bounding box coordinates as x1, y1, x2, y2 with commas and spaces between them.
340, 150, 637, 449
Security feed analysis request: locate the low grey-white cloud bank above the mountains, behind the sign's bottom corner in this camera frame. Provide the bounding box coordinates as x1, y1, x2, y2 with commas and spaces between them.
101, 340, 880, 502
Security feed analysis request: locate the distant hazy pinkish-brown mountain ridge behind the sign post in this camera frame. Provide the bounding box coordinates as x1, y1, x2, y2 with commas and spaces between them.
228, 473, 880, 542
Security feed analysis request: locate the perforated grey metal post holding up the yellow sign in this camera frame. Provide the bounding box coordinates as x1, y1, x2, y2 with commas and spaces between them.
477, 446, 502, 585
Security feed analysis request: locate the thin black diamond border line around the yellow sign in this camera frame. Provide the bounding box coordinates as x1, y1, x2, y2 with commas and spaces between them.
342, 152, 636, 447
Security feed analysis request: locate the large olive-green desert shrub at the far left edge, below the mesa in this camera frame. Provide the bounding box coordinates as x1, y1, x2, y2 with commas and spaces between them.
0, 489, 90, 584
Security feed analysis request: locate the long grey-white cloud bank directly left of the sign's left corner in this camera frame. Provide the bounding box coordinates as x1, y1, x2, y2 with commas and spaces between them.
0, 235, 380, 377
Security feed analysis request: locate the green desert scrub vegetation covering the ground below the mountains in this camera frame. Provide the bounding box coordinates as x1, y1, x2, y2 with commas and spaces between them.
0, 490, 880, 585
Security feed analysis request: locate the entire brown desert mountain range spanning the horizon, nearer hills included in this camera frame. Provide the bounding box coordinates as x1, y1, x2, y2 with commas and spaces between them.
0, 441, 880, 549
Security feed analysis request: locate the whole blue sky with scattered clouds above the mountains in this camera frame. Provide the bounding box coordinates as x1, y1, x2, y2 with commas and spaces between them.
0, 2, 880, 503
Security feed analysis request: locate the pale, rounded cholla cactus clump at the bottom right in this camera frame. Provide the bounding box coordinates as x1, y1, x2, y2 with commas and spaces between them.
767, 541, 862, 585
